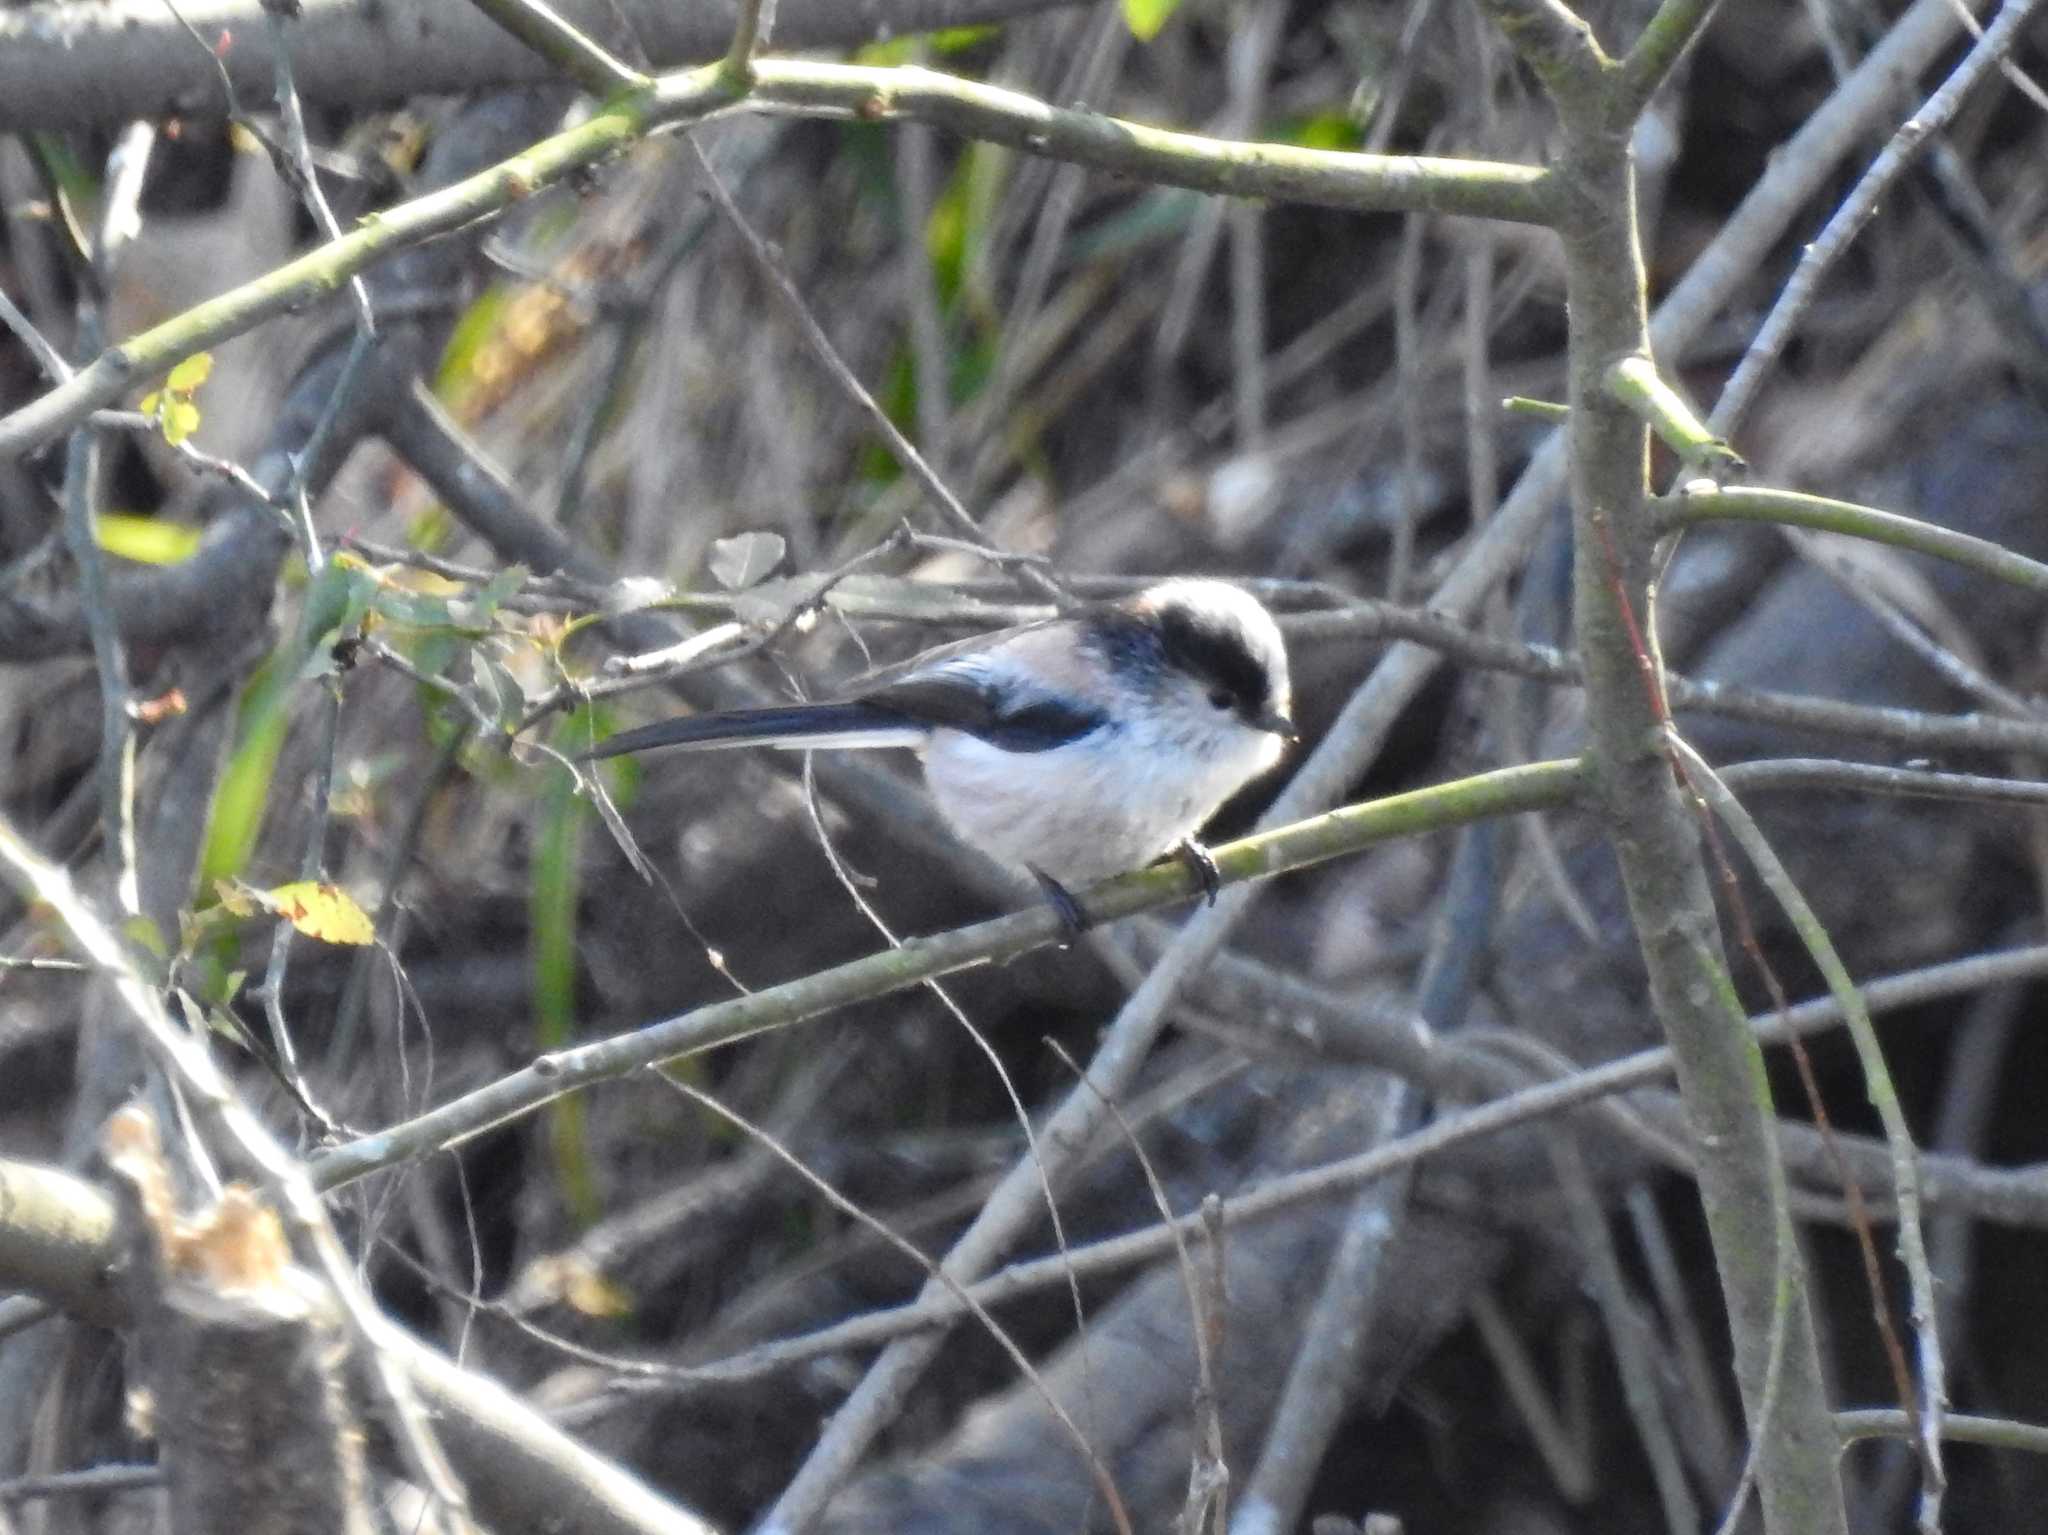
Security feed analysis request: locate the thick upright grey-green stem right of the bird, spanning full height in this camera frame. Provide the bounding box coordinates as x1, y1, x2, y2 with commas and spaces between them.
1489, 0, 1847, 1535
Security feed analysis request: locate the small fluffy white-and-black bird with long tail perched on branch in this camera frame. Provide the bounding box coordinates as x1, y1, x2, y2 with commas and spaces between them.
586, 579, 1294, 931
